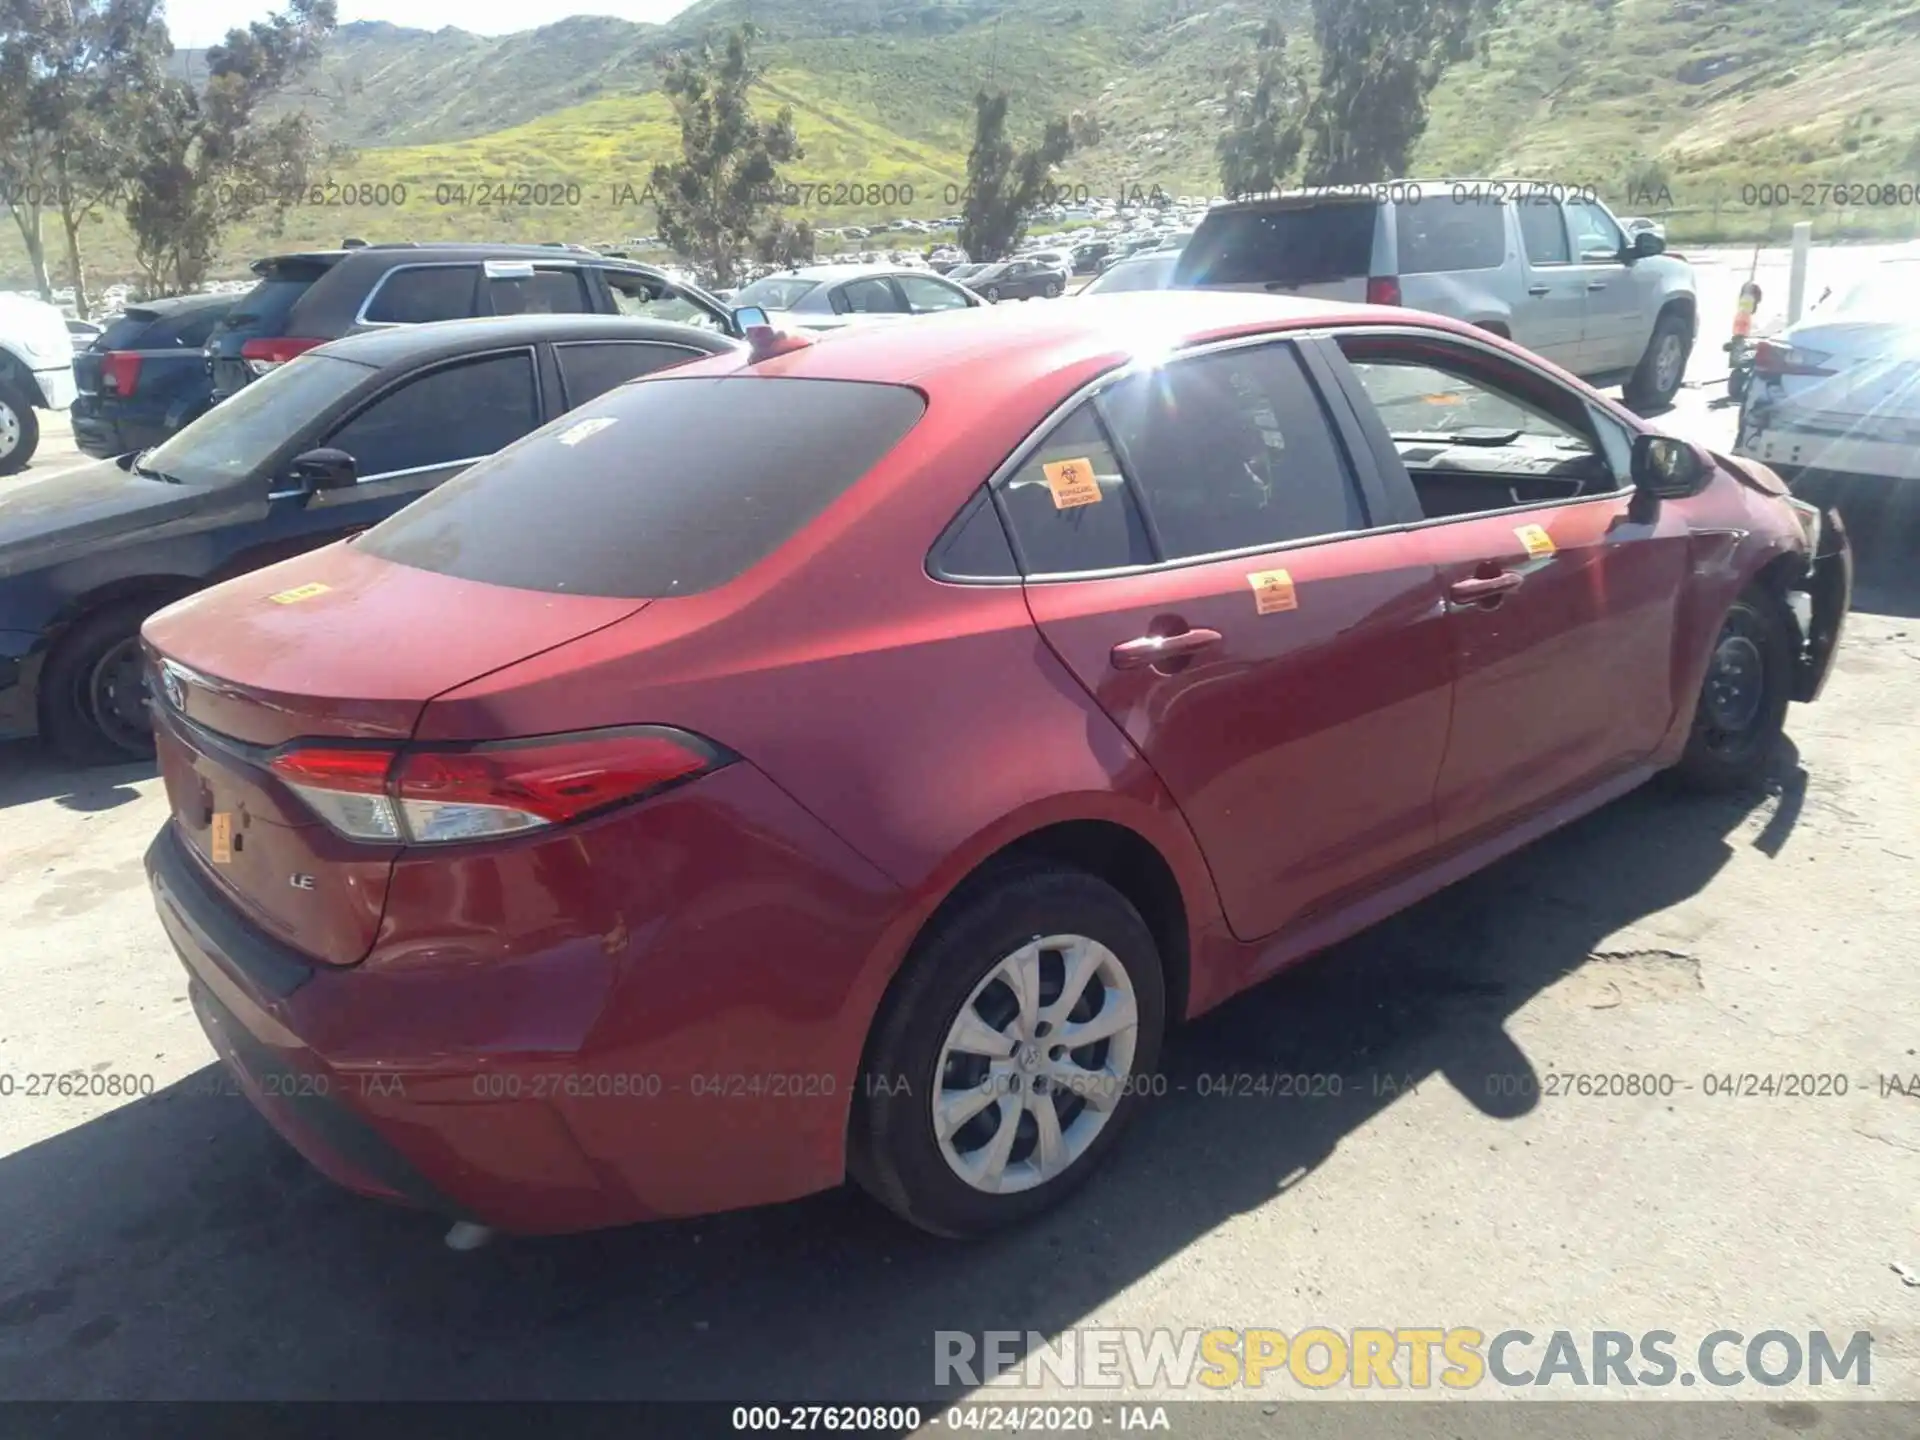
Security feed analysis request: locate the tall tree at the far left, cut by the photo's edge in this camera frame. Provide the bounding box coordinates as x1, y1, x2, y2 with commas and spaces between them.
0, 0, 171, 315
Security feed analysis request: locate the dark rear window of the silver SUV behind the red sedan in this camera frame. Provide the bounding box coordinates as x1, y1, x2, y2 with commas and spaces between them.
1173, 200, 1377, 286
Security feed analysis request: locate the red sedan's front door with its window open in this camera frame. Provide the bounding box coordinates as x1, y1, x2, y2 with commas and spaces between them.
1338, 332, 1692, 845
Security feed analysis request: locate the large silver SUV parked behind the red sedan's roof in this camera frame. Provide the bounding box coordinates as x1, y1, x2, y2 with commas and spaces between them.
1173, 180, 1697, 409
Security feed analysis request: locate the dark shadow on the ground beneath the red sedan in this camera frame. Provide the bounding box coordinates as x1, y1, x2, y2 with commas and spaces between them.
0, 745, 1799, 1413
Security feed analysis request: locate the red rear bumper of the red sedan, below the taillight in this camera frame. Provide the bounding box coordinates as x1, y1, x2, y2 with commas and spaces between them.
146, 764, 899, 1235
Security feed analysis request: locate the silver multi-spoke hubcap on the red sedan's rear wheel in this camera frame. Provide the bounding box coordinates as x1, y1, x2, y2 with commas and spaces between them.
931, 935, 1140, 1194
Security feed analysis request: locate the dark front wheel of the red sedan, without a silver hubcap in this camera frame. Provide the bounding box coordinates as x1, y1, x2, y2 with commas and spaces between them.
1672, 588, 1797, 793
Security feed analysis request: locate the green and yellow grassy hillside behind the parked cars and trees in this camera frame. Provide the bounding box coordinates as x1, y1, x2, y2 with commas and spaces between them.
0, 0, 1920, 284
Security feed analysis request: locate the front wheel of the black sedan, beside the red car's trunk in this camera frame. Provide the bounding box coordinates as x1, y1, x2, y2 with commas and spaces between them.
40, 603, 156, 766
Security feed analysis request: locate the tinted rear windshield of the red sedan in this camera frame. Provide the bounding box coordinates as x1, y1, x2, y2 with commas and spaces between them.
360, 374, 925, 599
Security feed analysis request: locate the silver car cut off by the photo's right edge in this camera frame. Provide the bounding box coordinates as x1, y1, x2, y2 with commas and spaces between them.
1734, 252, 1920, 480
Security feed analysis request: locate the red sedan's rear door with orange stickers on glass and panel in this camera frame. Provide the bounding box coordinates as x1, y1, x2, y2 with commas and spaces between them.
996, 342, 1452, 939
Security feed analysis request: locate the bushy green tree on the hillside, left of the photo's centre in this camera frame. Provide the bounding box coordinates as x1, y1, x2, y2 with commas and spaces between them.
653, 25, 794, 286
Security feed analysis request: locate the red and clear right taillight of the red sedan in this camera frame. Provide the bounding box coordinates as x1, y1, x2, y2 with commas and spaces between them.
269, 726, 733, 845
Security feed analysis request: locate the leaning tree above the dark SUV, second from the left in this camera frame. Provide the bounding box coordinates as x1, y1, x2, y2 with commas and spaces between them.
127, 0, 334, 294
